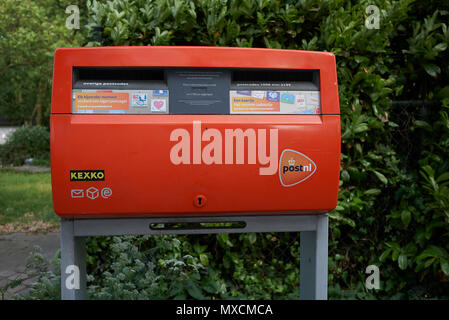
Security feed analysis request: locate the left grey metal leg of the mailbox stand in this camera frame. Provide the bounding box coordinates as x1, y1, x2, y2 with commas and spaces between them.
61, 219, 86, 300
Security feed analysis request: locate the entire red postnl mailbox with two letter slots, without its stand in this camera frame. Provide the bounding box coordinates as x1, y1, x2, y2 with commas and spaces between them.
51, 47, 340, 218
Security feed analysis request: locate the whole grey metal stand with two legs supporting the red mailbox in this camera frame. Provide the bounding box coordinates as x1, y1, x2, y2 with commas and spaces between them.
61, 214, 328, 300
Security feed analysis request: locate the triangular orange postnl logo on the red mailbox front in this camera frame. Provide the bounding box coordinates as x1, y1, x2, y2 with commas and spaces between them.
279, 149, 316, 187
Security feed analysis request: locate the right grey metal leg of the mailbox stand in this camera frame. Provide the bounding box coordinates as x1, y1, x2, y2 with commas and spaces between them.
299, 214, 329, 300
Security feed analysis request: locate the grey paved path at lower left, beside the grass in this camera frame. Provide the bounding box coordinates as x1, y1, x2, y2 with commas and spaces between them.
0, 232, 59, 299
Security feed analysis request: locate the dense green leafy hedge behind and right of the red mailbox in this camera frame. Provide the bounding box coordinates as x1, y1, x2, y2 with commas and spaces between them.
21, 0, 449, 299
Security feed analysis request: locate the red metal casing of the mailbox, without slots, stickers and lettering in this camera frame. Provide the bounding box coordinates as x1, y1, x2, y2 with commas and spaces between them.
51, 47, 340, 217
